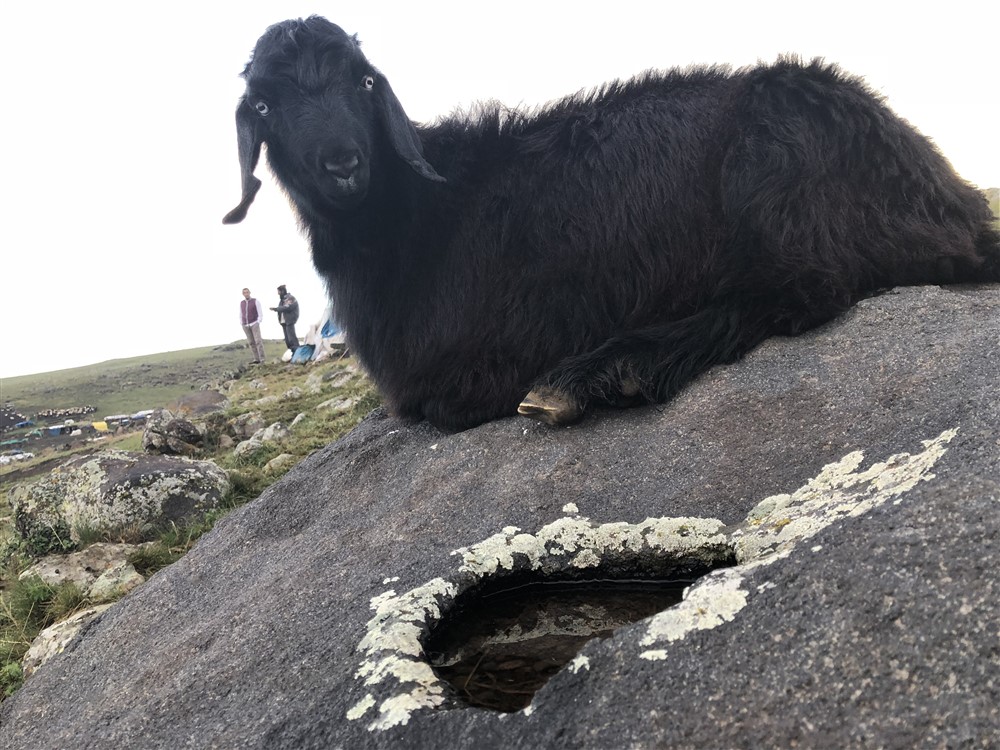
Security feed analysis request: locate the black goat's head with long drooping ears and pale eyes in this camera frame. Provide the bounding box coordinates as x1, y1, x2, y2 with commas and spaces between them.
223, 16, 444, 224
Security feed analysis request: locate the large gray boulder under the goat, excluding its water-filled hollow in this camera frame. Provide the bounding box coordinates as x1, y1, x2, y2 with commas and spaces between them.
0, 286, 1000, 750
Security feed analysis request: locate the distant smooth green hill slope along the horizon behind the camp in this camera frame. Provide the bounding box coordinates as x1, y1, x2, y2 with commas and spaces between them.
0, 341, 285, 419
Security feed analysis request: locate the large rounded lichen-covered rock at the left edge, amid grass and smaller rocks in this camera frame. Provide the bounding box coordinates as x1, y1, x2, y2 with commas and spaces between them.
9, 451, 229, 554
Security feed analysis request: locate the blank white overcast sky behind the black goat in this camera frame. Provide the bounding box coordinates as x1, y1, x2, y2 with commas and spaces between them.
0, 0, 1000, 382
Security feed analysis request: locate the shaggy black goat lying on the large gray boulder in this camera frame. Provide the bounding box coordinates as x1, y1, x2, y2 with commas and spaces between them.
224, 17, 1000, 428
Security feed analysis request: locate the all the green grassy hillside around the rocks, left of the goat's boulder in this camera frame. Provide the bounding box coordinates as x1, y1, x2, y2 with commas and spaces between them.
0, 342, 379, 701
